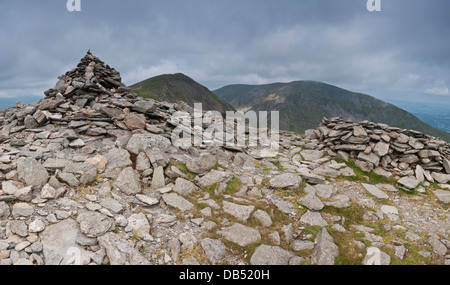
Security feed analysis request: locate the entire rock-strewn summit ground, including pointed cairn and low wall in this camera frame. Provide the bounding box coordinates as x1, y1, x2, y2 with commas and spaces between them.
0, 53, 450, 265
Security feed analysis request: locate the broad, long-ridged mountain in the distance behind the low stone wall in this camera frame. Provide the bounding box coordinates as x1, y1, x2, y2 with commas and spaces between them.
214, 81, 450, 141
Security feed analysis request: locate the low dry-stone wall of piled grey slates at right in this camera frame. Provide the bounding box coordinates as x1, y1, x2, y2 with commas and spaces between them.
306, 117, 450, 189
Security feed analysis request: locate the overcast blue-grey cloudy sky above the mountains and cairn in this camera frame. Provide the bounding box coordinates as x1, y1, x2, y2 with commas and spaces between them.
0, 0, 450, 104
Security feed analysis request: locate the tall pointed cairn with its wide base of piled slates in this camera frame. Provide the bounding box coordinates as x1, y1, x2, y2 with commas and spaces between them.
0, 52, 197, 147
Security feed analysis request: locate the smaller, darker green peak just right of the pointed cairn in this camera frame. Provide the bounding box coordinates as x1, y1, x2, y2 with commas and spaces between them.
130, 73, 234, 113
